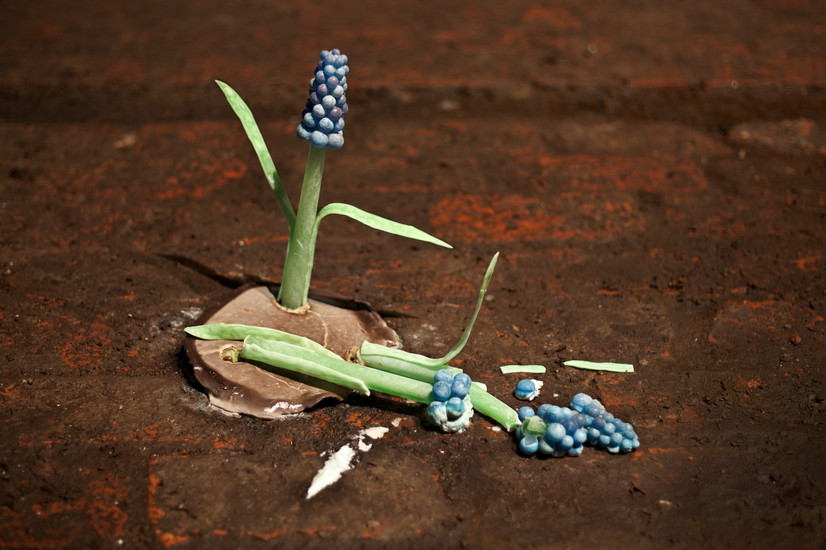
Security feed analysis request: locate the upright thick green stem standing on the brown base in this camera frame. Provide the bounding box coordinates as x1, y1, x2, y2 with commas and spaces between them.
278, 145, 327, 309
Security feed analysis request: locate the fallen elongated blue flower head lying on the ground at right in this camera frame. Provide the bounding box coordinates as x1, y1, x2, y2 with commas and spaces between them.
516, 393, 640, 457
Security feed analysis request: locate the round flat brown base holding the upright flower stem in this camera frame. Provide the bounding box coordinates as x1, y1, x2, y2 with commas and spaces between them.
184, 285, 401, 419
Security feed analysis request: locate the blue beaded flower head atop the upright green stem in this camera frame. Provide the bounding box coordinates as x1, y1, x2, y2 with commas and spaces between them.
296, 50, 350, 149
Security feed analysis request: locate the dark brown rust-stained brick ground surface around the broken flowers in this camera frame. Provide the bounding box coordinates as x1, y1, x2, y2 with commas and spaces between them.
0, 0, 826, 549
